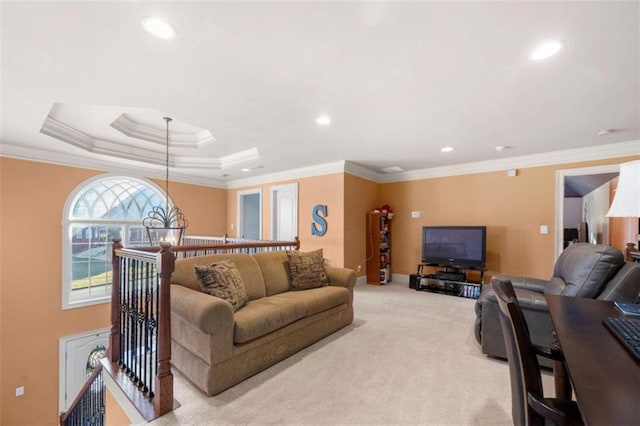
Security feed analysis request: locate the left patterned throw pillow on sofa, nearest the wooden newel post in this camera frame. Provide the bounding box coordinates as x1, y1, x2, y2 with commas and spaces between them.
194, 259, 248, 312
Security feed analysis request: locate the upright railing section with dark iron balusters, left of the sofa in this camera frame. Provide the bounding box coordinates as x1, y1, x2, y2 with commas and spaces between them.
107, 240, 174, 420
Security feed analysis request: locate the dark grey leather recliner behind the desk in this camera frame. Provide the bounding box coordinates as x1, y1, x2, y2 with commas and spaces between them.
475, 243, 640, 367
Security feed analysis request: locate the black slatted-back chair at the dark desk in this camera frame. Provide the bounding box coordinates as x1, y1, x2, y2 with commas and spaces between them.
491, 280, 582, 426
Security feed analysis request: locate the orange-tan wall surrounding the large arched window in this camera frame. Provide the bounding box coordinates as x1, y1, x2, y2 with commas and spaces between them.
0, 157, 226, 425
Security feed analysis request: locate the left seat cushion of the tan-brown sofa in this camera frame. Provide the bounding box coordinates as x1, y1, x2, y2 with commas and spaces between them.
233, 294, 306, 343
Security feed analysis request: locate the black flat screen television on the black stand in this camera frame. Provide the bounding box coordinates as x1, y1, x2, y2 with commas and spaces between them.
422, 226, 487, 268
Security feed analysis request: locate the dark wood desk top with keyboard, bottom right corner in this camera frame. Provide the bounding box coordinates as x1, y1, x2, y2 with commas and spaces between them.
545, 295, 640, 425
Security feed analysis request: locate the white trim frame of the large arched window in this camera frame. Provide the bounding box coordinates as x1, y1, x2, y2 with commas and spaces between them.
62, 173, 166, 310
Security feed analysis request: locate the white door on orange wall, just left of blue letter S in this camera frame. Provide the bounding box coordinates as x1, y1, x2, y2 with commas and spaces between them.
271, 183, 299, 241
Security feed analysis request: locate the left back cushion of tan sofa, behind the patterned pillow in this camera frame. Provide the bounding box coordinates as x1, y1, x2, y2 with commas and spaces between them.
171, 253, 266, 300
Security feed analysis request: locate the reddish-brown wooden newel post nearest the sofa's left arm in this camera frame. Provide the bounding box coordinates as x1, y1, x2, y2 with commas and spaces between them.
153, 243, 175, 416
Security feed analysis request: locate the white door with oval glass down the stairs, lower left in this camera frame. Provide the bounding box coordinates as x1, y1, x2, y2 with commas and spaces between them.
59, 328, 110, 411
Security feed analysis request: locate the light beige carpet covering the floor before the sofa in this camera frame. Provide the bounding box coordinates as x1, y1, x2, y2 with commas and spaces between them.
153, 283, 553, 425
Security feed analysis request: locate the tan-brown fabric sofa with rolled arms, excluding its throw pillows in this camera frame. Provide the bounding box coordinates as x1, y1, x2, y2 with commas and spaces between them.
171, 251, 356, 396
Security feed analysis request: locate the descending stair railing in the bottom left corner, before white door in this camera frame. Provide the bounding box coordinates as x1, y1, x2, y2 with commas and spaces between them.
60, 363, 105, 426
